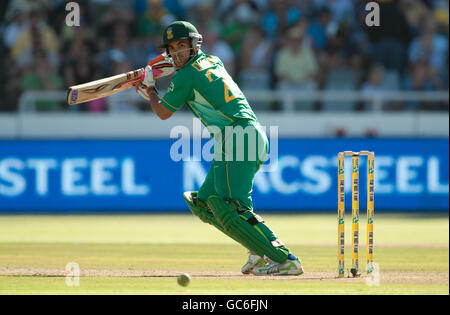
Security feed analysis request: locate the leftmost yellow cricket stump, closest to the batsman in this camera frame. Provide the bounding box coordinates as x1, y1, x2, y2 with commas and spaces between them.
337, 153, 345, 278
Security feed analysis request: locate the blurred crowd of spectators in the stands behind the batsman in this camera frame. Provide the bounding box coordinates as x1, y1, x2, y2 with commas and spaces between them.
0, 0, 449, 112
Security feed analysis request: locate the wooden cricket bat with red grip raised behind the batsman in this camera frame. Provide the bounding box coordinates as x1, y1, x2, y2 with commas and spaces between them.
67, 53, 175, 105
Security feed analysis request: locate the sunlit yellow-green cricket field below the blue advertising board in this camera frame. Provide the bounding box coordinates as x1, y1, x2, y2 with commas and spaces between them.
0, 213, 449, 295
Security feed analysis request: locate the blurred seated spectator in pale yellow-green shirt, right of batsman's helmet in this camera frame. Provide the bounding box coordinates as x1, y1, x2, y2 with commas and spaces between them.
275, 27, 318, 110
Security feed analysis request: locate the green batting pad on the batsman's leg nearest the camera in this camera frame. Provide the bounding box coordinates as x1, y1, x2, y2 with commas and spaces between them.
207, 195, 289, 264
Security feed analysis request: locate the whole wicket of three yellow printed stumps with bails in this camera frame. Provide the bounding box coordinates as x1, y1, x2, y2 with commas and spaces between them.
338, 151, 375, 278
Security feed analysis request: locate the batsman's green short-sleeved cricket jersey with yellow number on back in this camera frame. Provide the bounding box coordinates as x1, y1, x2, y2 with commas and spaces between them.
161, 50, 257, 130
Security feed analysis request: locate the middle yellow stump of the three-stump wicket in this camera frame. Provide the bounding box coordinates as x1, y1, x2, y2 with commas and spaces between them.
351, 153, 359, 277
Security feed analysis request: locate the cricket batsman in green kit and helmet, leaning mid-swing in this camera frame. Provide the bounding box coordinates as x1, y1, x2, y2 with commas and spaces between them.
136, 21, 303, 276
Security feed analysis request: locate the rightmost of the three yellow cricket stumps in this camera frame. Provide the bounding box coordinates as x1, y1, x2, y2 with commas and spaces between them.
366, 152, 375, 274
